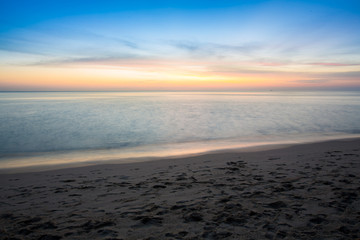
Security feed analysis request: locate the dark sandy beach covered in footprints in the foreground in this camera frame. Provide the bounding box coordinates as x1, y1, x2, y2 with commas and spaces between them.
0, 139, 360, 240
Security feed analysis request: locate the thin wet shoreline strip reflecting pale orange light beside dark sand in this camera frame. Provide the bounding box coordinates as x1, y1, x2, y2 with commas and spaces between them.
0, 134, 360, 172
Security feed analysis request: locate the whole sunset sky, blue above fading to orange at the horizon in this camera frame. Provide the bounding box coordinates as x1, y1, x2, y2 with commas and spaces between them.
0, 0, 360, 91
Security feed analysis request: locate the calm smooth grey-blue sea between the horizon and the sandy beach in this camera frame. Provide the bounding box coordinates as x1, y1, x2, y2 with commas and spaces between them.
0, 92, 360, 168
